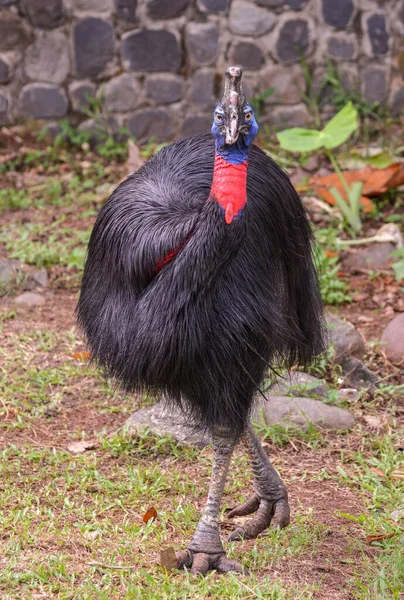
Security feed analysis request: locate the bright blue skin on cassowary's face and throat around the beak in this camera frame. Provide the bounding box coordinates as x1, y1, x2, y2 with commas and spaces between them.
212, 104, 258, 165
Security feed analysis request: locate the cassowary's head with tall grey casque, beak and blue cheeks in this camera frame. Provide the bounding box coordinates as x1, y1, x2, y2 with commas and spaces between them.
212, 67, 258, 150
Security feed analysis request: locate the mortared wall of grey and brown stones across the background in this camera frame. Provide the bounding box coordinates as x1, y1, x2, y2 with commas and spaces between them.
0, 0, 404, 140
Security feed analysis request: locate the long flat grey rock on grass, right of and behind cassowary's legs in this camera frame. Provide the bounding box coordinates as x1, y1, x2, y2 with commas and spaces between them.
252, 394, 355, 430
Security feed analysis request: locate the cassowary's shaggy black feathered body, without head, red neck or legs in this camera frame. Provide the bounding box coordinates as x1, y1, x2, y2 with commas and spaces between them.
78, 136, 323, 429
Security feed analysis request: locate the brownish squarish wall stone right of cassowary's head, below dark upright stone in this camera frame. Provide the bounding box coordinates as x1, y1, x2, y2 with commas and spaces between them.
259, 65, 306, 105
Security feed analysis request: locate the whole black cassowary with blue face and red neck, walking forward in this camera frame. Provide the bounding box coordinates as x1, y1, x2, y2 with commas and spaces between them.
78, 67, 323, 574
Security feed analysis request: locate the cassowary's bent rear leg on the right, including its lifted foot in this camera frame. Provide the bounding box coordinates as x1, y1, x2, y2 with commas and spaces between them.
227, 423, 290, 541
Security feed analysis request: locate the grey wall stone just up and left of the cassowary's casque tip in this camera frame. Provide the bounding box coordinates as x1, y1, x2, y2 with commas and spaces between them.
185, 23, 219, 65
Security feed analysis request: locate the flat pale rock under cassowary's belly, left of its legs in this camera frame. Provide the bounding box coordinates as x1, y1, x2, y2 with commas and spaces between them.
127, 401, 210, 448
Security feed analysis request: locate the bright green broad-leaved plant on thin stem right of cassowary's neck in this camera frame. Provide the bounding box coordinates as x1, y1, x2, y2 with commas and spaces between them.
277, 102, 363, 232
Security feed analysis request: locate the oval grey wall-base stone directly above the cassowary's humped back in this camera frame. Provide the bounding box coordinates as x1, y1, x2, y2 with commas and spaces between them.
127, 108, 174, 142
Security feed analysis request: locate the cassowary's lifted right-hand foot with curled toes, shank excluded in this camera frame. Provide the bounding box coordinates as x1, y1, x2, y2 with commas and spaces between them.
226, 489, 290, 542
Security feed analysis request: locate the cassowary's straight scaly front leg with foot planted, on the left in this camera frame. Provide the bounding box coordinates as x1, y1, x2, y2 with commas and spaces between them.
177, 431, 247, 575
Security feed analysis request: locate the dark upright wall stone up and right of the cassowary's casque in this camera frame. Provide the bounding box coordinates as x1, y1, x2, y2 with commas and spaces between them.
276, 19, 310, 63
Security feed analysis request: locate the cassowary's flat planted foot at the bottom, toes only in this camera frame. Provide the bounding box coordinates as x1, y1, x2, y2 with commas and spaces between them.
176, 549, 249, 576
